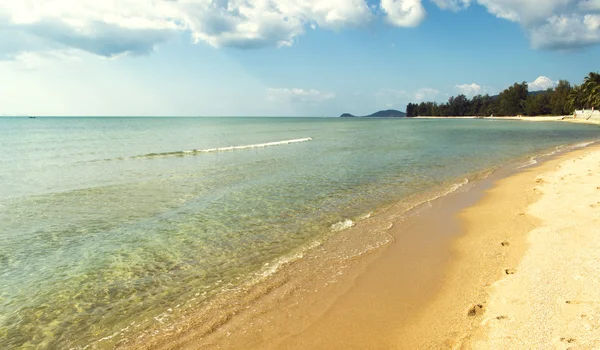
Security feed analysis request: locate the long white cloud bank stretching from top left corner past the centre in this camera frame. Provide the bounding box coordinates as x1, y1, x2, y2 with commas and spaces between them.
0, 0, 373, 57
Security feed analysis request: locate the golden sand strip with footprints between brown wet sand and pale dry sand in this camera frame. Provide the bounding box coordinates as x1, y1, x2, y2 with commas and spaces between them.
390, 144, 600, 349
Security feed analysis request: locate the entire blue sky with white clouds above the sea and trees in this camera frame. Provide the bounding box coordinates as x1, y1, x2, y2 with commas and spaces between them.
0, 0, 600, 116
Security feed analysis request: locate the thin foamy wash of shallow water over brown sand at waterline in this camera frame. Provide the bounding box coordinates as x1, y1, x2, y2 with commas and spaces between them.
116, 171, 486, 349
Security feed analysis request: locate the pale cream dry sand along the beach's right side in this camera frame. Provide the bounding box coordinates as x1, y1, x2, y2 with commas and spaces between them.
469, 144, 600, 349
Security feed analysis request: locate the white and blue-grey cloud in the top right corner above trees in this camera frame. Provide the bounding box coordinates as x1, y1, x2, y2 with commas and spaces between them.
477, 0, 600, 49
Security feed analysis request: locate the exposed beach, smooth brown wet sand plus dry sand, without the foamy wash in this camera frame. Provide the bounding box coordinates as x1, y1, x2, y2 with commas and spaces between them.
280, 146, 600, 349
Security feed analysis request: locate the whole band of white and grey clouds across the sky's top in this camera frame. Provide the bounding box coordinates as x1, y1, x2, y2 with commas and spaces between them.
0, 0, 600, 59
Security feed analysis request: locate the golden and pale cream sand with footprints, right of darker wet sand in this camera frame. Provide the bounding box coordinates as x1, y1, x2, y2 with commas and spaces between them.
390, 146, 600, 349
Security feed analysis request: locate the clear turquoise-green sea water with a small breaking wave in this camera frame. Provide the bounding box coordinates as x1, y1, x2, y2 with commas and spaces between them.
0, 118, 600, 349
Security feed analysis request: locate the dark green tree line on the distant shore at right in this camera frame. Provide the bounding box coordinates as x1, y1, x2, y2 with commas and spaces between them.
406, 72, 600, 117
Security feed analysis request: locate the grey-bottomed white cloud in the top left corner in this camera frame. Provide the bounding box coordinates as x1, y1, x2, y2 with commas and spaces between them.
0, 0, 183, 56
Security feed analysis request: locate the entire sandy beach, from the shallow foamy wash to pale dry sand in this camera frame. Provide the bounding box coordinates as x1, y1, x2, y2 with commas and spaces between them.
127, 139, 600, 349
